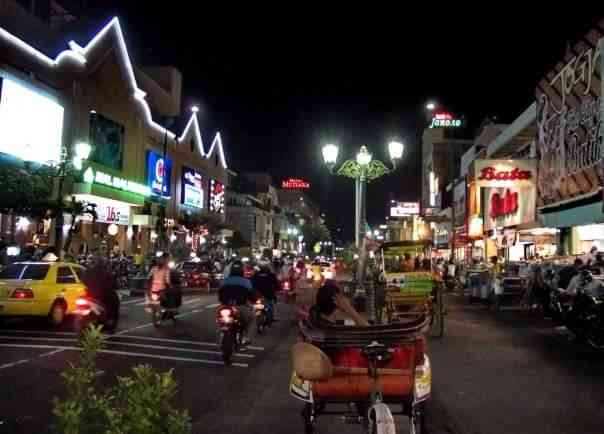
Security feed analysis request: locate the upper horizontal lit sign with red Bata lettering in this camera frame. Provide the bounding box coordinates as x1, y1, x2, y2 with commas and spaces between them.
474, 160, 536, 187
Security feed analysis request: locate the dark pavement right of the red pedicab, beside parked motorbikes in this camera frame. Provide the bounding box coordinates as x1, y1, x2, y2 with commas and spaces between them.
429, 294, 604, 434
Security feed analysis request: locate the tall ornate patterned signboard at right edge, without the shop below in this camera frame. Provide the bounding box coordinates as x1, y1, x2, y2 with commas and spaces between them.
535, 21, 604, 206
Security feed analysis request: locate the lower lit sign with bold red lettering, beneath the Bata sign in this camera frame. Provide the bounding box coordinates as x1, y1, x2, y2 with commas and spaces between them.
484, 186, 536, 231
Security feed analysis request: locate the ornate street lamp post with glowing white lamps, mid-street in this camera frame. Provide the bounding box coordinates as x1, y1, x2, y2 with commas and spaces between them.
322, 141, 404, 248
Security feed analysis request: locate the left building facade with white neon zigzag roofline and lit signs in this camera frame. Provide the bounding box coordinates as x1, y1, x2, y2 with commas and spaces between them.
0, 5, 228, 254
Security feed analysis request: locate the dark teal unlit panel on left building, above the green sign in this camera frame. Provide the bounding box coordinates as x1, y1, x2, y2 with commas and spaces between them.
89, 112, 126, 170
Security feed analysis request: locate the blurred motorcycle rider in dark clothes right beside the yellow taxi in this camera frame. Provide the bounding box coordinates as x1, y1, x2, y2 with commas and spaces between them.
82, 255, 120, 332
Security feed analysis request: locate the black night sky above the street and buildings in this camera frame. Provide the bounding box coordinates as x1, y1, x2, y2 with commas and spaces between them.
81, 6, 604, 239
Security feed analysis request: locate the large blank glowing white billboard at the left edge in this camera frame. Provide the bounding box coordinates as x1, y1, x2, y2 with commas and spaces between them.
0, 77, 64, 164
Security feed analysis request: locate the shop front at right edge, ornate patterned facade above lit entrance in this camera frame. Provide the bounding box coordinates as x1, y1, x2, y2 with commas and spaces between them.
535, 24, 604, 259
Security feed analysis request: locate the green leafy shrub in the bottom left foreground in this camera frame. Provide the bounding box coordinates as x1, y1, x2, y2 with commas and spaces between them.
53, 326, 192, 434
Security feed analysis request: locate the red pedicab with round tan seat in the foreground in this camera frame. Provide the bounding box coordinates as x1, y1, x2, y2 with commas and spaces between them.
290, 311, 431, 434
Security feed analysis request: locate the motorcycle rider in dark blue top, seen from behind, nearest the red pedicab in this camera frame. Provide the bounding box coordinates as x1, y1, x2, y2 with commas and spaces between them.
218, 260, 255, 344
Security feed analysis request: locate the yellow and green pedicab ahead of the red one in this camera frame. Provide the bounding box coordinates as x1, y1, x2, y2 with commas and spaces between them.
380, 240, 445, 337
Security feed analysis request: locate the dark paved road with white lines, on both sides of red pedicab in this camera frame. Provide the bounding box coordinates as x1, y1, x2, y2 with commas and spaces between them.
0, 286, 604, 434
